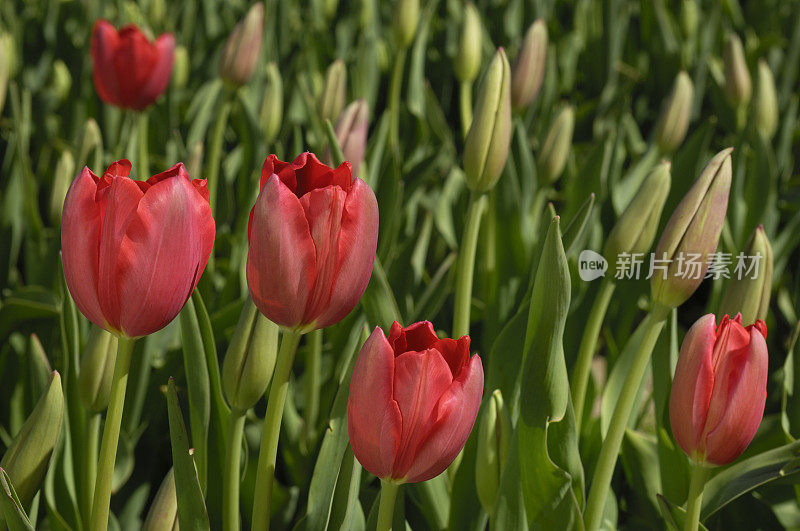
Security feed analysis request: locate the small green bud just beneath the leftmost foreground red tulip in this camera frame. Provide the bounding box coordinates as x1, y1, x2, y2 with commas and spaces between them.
78, 326, 117, 413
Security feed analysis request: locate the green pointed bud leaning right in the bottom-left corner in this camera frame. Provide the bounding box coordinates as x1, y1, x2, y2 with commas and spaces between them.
0, 371, 64, 507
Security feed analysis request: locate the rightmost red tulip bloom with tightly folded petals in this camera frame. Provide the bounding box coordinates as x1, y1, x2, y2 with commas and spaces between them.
669, 314, 768, 465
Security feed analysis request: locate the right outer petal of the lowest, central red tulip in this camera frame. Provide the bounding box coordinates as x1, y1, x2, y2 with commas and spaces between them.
406, 355, 483, 483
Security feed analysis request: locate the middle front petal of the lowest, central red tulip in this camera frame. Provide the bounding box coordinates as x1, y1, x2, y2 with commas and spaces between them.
392, 349, 453, 479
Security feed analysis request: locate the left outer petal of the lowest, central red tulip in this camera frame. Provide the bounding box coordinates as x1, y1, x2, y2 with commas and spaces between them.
347, 328, 402, 478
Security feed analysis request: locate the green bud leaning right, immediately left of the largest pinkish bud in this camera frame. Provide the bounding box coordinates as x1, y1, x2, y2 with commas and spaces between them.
603, 161, 672, 271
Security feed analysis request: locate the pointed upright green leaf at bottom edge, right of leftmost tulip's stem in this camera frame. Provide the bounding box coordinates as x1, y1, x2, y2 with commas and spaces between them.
167, 378, 211, 530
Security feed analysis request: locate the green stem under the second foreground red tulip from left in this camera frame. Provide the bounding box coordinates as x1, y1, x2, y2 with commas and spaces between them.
252, 330, 302, 531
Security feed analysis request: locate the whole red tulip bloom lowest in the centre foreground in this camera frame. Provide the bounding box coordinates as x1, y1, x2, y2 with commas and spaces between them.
347, 321, 483, 483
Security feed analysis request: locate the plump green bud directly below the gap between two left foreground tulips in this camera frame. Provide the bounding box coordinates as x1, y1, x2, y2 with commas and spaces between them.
222, 297, 278, 411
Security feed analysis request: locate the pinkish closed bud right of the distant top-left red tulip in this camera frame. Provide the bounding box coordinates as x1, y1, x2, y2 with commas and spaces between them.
219, 2, 264, 86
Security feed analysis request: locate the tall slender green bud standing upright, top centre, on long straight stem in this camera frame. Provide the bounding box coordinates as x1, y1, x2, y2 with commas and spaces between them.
464, 48, 511, 192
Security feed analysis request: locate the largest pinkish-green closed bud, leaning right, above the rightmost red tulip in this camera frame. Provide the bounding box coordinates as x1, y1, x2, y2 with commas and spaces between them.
650, 148, 733, 308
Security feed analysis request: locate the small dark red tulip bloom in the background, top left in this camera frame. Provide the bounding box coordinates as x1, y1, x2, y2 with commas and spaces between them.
91, 20, 175, 111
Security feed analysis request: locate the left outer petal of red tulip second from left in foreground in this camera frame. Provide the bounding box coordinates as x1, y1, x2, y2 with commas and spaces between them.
247, 176, 316, 327
